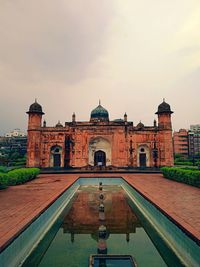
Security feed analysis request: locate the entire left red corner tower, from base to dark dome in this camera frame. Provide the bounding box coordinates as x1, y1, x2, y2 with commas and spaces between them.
26, 100, 44, 167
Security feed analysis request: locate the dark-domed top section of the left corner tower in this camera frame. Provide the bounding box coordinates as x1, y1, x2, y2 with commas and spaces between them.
26, 100, 44, 129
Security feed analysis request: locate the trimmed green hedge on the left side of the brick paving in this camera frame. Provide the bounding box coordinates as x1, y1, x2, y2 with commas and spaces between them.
0, 168, 40, 188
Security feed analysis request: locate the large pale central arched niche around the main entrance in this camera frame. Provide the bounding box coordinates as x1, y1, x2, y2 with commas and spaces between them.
88, 136, 111, 166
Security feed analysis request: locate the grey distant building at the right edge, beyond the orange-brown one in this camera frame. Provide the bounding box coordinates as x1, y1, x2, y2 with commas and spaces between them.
188, 124, 200, 157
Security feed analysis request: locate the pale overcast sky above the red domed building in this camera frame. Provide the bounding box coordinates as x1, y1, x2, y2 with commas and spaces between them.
0, 0, 200, 135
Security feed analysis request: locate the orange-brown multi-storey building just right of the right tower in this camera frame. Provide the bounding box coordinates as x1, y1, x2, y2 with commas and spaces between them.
173, 129, 189, 158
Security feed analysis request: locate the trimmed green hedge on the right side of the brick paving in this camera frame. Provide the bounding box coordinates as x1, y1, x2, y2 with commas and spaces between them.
161, 167, 200, 187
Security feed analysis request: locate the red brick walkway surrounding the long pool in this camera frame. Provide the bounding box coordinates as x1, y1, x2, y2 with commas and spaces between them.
0, 174, 200, 251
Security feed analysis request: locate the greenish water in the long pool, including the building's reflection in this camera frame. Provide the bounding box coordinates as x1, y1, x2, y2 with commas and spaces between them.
23, 186, 182, 267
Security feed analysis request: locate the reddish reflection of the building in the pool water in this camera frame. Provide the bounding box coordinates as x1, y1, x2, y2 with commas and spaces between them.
62, 186, 141, 247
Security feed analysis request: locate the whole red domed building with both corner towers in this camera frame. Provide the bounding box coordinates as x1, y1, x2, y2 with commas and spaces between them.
27, 101, 174, 168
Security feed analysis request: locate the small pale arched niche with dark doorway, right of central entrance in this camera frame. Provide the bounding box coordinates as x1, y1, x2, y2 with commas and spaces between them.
137, 144, 150, 168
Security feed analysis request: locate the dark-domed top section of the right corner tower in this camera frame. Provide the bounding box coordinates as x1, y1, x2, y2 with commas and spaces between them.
155, 99, 173, 130
